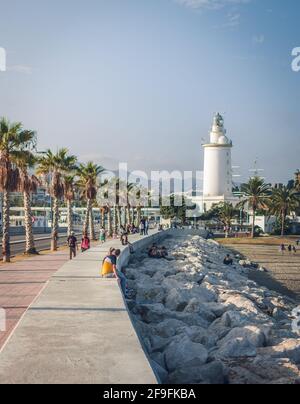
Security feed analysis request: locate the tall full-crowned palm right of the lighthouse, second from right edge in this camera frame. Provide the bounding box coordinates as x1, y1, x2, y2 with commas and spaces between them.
239, 176, 270, 238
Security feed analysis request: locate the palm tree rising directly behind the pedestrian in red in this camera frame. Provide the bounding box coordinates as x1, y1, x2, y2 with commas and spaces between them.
77, 162, 104, 240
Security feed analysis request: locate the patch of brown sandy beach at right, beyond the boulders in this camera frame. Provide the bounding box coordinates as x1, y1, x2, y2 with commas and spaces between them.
225, 244, 300, 302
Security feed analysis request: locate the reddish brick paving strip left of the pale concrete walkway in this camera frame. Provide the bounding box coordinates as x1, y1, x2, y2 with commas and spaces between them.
0, 250, 69, 349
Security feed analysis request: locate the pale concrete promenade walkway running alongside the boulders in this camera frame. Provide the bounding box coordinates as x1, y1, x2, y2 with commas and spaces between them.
0, 232, 157, 384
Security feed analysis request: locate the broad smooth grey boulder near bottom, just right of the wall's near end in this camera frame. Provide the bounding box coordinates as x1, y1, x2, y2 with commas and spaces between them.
165, 336, 208, 372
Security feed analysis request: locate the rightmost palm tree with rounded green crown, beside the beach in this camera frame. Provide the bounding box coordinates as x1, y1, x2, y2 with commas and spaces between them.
270, 187, 300, 237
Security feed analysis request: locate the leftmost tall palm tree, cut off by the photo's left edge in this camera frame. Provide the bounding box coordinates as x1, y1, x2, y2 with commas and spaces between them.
0, 118, 36, 262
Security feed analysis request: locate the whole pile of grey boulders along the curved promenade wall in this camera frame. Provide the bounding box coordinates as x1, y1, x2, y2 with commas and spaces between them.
125, 236, 300, 384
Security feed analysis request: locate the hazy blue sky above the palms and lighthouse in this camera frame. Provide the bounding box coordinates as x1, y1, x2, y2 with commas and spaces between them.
0, 0, 300, 181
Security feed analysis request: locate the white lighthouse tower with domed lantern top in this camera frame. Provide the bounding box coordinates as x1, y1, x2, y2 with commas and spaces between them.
203, 113, 235, 211
